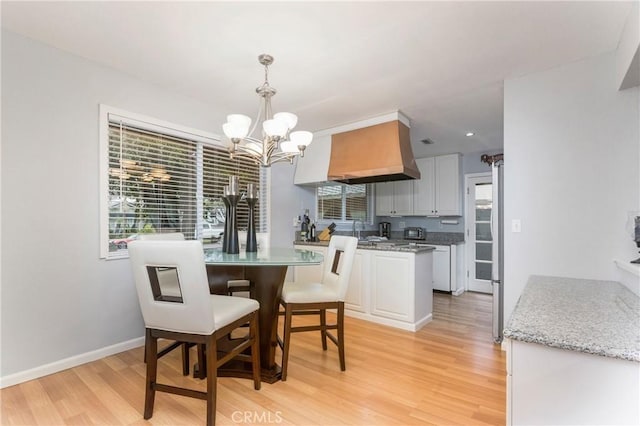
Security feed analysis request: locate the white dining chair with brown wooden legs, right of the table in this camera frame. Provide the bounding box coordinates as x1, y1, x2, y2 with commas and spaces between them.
278, 235, 358, 381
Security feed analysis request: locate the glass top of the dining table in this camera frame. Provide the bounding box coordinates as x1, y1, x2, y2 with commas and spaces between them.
204, 247, 324, 266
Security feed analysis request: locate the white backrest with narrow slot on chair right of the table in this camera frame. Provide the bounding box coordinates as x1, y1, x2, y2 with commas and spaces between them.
322, 235, 358, 301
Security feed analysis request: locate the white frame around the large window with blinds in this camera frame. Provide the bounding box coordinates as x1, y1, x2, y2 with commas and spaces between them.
98, 104, 271, 260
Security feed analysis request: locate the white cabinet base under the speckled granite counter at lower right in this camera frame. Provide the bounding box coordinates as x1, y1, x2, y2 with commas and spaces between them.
505, 340, 640, 425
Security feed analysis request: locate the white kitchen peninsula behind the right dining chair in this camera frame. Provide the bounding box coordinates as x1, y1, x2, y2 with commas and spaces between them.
294, 241, 433, 331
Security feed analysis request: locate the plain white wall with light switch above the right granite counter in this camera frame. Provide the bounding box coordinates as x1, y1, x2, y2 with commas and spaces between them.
504, 54, 640, 318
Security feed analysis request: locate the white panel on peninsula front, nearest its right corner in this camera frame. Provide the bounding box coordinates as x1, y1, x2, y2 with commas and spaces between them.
371, 252, 413, 321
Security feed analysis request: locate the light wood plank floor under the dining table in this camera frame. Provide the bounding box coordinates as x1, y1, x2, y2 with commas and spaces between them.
0, 293, 506, 425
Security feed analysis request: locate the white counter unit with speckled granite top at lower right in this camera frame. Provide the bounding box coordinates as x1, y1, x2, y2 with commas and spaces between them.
504, 276, 640, 425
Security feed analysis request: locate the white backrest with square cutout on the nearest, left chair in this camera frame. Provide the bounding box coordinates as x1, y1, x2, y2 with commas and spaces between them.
129, 240, 215, 334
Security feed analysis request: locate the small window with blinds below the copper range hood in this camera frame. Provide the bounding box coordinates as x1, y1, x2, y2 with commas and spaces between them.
316, 184, 372, 223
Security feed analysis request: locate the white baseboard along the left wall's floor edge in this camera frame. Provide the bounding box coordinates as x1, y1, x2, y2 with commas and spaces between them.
0, 337, 144, 389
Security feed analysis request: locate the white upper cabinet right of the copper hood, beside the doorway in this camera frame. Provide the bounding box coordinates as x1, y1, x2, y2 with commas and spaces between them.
413, 154, 462, 216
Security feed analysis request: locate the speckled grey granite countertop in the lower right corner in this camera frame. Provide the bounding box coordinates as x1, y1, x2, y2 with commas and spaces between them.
504, 275, 640, 362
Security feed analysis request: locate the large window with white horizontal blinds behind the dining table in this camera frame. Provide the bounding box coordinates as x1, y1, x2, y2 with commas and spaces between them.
101, 106, 267, 258
